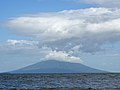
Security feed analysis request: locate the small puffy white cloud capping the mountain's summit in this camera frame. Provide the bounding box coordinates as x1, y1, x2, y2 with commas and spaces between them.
45, 51, 82, 63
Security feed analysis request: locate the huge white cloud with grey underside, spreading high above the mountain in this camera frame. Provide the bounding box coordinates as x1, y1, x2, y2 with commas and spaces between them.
7, 8, 120, 53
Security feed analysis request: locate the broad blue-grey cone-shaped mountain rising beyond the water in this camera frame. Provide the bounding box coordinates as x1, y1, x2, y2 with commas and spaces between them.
11, 60, 105, 73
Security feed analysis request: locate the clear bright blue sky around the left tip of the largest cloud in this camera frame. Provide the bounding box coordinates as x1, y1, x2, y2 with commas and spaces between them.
0, 0, 93, 41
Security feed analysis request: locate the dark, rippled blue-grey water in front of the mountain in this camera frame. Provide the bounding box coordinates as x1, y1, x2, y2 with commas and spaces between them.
0, 74, 120, 90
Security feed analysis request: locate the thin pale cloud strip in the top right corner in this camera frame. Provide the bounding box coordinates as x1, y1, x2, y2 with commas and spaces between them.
74, 0, 120, 7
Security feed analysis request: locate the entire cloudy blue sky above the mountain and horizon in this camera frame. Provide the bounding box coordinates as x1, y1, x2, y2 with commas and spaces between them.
0, 0, 120, 72
